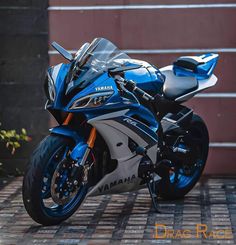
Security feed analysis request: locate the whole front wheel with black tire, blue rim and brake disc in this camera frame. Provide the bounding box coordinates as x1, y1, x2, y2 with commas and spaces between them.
22, 135, 87, 225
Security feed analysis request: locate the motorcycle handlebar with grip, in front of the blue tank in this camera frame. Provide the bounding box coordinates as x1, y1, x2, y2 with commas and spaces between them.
115, 75, 154, 101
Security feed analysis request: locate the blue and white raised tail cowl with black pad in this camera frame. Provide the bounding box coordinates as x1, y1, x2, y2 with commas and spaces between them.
173, 53, 219, 80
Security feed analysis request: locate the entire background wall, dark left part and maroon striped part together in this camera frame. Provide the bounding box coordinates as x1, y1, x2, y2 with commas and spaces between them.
0, 0, 236, 174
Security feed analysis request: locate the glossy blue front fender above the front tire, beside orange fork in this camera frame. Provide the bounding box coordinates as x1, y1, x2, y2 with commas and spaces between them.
50, 126, 88, 162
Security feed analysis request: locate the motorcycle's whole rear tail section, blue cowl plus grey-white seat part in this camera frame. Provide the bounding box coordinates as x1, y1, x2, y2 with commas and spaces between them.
160, 53, 219, 102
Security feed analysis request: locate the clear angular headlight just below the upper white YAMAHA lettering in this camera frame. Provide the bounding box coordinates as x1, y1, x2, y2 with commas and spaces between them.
70, 91, 113, 110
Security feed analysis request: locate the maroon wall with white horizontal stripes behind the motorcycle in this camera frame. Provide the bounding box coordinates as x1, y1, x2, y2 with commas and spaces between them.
49, 0, 236, 174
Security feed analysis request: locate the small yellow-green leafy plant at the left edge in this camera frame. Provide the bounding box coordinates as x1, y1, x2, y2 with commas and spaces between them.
0, 123, 31, 154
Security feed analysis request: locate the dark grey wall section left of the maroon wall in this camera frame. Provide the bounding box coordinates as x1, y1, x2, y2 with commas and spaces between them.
0, 0, 49, 173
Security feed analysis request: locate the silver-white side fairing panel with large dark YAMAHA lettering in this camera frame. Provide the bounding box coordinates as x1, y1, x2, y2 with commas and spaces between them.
88, 110, 157, 195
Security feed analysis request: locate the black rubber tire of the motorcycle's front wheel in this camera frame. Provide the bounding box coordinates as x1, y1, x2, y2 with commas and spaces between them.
22, 135, 87, 225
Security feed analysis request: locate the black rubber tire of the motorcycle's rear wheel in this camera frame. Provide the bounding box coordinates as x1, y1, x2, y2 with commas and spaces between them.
159, 114, 209, 200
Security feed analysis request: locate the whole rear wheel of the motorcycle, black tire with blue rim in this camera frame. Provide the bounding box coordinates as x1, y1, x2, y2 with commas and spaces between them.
159, 115, 209, 199
